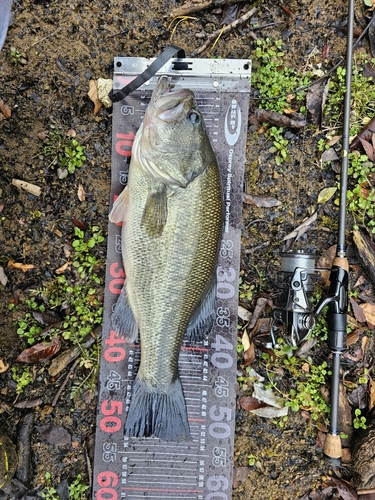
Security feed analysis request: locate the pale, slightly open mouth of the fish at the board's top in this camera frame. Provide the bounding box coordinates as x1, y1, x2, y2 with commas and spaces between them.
153, 76, 194, 122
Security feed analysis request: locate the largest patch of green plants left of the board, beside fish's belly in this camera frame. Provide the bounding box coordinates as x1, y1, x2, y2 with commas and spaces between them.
13, 226, 104, 397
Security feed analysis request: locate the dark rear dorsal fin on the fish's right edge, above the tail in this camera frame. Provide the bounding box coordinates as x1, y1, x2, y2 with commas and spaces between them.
186, 278, 216, 342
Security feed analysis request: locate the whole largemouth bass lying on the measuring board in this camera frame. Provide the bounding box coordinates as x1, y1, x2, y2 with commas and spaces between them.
109, 75, 223, 441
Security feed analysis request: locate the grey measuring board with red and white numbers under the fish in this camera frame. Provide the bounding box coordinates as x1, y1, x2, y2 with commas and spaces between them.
93, 58, 251, 500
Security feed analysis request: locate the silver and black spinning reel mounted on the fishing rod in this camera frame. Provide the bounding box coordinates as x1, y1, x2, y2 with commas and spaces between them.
271, 252, 347, 347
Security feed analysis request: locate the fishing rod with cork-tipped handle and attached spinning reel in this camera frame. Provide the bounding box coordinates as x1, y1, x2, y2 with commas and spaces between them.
271, 0, 354, 464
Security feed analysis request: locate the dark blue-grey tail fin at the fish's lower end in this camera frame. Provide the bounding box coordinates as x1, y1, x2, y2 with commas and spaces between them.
125, 377, 191, 441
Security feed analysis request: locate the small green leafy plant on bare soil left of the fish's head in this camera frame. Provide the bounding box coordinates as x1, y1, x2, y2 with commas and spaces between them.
43, 130, 86, 174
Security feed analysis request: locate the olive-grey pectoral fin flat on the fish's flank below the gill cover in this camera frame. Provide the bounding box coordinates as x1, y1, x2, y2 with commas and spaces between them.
141, 184, 168, 238
